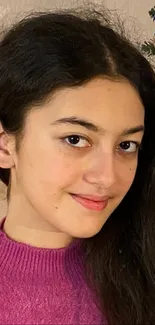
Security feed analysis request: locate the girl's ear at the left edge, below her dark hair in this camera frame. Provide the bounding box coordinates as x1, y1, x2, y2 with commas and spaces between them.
0, 122, 14, 168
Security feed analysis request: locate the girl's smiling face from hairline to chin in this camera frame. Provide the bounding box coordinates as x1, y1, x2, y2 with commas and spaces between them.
8, 78, 144, 243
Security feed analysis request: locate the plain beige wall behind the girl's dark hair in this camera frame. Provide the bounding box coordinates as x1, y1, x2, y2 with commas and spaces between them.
0, 0, 155, 217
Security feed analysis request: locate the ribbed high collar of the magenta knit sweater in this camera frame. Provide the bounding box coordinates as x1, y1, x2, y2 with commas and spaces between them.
0, 218, 83, 284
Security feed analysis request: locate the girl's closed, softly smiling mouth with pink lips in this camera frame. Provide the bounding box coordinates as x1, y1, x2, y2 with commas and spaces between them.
70, 193, 109, 211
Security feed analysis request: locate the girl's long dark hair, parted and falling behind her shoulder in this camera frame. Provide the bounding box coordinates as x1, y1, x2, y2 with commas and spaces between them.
0, 6, 155, 325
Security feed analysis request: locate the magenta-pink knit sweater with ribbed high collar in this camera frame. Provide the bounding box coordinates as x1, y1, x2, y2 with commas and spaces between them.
0, 219, 106, 325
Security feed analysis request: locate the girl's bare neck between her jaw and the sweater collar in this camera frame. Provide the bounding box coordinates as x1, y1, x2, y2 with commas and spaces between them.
3, 213, 74, 248
